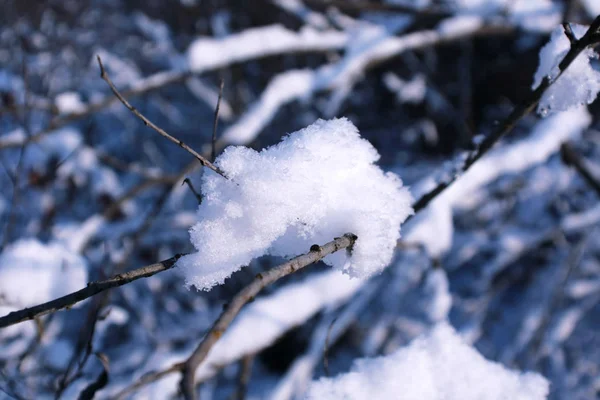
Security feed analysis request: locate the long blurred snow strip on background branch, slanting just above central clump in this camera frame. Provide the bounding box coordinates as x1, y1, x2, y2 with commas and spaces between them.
222, 17, 514, 144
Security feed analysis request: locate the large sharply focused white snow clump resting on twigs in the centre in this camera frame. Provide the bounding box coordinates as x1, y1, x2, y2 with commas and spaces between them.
178, 119, 412, 290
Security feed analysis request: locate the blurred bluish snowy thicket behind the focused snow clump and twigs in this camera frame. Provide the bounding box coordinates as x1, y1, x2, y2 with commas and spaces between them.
0, 0, 600, 399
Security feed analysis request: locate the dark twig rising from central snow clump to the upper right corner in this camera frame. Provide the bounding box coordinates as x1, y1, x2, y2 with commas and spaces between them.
409, 16, 600, 219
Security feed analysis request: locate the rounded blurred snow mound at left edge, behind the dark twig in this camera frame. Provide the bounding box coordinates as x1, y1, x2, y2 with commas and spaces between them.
0, 239, 87, 311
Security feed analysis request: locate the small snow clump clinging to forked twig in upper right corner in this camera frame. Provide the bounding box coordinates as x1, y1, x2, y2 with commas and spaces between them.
533, 24, 600, 115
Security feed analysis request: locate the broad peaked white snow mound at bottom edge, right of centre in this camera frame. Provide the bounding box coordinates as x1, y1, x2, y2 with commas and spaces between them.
307, 323, 549, 400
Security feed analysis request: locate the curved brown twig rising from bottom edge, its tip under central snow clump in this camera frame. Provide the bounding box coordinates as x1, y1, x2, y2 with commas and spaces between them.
180, 233, 357, 400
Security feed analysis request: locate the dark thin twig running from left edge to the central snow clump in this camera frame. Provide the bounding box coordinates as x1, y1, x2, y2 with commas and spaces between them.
0, 254, 182, 328
